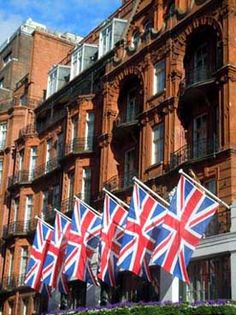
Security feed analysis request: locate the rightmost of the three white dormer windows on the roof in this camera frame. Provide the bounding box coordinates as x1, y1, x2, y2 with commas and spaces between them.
99, 18, 127, 57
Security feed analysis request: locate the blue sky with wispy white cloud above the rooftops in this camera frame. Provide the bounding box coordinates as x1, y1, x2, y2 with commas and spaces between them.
0, 0, 121, 44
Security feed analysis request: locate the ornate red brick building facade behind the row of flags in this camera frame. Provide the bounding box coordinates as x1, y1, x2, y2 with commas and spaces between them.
0, 0, 236, 314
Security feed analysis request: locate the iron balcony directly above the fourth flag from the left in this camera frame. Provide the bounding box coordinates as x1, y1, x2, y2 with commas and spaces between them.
104, 170, 138, 192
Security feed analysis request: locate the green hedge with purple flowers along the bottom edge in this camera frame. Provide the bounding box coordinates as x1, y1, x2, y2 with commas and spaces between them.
45, 301, 236, 315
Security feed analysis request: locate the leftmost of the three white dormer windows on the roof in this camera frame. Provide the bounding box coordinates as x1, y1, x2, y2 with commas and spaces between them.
47, 65, 70, 98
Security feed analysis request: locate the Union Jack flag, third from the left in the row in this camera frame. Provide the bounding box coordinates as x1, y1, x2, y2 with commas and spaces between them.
64, 199, 101, 284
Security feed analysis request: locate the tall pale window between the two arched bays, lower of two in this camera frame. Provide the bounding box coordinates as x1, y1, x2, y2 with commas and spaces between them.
152, 123, 164, 164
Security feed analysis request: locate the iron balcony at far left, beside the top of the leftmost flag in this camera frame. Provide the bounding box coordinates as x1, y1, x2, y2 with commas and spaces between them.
2, 219, 37, 239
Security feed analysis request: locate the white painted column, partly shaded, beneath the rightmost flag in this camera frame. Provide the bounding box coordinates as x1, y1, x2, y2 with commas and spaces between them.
160, 269, 179, 303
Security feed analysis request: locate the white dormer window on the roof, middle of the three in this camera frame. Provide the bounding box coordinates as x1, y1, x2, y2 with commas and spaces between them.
70, 44, 98, 80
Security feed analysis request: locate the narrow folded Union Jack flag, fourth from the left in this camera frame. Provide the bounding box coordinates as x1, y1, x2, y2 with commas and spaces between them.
98, 194, 127, 286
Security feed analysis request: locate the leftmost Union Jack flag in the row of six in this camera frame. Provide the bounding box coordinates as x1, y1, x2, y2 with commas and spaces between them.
25, 220, 52, 292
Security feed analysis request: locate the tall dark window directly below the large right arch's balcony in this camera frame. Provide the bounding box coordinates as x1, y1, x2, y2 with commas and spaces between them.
193, 114, 207, 158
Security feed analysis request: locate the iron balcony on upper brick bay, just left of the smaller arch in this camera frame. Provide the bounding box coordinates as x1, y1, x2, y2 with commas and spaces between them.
65, 137, 95, 155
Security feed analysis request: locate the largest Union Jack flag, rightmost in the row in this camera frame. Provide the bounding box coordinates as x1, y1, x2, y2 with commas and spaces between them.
150, 175, 219, 283
